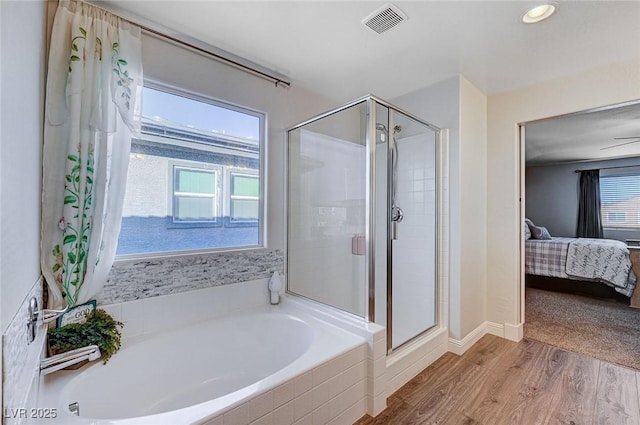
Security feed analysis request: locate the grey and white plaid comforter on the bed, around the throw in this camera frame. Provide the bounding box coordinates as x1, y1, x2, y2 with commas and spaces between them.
525, 238, 636, 296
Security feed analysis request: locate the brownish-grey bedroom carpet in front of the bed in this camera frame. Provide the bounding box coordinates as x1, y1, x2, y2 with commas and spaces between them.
524, 288, 640, 370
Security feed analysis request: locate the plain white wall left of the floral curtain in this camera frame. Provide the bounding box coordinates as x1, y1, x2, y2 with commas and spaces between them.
0, 1, 46, 407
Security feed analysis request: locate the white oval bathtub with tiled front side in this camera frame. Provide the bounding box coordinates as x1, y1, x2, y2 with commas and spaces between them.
34, 300, 367, 425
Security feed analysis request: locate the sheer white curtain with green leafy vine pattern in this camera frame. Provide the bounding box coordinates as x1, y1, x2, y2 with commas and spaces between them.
41, 1, 142, 308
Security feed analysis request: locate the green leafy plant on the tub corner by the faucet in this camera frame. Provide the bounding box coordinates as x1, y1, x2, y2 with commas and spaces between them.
48, 309, 123, 364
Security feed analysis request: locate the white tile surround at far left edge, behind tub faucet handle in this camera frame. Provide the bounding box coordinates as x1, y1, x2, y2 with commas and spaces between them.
2, 278, 46, 425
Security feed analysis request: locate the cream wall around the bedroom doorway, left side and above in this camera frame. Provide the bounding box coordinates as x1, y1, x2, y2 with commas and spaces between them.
487, 59, 640, 328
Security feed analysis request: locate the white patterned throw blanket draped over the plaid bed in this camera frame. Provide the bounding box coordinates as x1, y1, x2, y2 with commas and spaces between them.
566, 238, 631, 288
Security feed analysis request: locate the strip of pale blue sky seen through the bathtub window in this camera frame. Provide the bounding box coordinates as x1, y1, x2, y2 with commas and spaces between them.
142, 87, 260, 140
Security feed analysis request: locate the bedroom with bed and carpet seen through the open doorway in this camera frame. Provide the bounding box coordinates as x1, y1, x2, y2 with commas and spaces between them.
520, 101, 640, 370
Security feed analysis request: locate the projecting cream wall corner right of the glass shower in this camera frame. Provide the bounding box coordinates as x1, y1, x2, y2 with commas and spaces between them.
393, 76, 487, 340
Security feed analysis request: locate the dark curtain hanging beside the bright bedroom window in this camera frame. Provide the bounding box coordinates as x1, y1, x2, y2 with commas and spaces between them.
578, 170, 603, 238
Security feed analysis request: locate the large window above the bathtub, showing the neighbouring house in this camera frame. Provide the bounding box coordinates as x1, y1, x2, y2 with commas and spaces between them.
117, 86, 265, 255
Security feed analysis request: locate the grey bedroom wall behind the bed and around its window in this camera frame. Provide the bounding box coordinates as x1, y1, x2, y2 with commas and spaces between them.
525, 157, 640, 241
